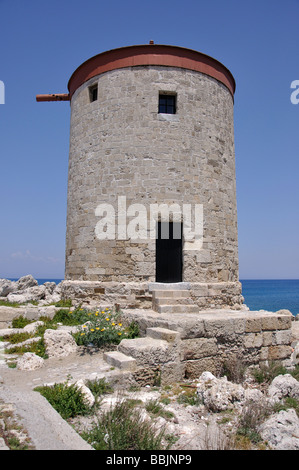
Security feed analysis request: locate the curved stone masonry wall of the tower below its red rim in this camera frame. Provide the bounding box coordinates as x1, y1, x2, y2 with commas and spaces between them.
65, 66, 238, 290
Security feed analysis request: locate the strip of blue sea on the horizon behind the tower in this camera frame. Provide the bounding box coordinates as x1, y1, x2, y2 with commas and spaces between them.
7, 279, 299, 315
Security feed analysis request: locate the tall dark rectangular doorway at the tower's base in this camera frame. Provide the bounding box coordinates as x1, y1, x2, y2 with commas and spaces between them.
156, 222, 183, 282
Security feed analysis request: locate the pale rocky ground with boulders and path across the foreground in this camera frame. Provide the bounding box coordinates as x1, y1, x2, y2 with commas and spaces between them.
0, 276, 299, 450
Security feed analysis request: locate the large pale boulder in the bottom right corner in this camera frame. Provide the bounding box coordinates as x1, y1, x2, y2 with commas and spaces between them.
260, 409, 299, 450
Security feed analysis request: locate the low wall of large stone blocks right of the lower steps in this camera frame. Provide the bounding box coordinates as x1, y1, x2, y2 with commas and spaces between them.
125, 310, 293, 380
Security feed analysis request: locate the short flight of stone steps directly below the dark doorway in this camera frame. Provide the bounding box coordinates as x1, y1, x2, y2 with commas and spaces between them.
152, 285, 199, 313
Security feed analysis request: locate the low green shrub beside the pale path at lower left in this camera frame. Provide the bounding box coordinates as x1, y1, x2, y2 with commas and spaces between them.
35, 382, 91, 419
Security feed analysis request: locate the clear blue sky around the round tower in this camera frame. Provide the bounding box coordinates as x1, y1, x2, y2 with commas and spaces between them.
0, 0, 299, 279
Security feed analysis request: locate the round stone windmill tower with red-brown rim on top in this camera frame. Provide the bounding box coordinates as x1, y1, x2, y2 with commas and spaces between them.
63, 42, 242, 310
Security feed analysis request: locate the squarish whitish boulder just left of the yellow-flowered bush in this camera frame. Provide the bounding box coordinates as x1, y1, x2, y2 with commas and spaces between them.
44, 330, 77, 357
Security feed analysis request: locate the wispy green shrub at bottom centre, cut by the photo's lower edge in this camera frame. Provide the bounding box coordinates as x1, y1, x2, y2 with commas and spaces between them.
82, 401, 170, 450
